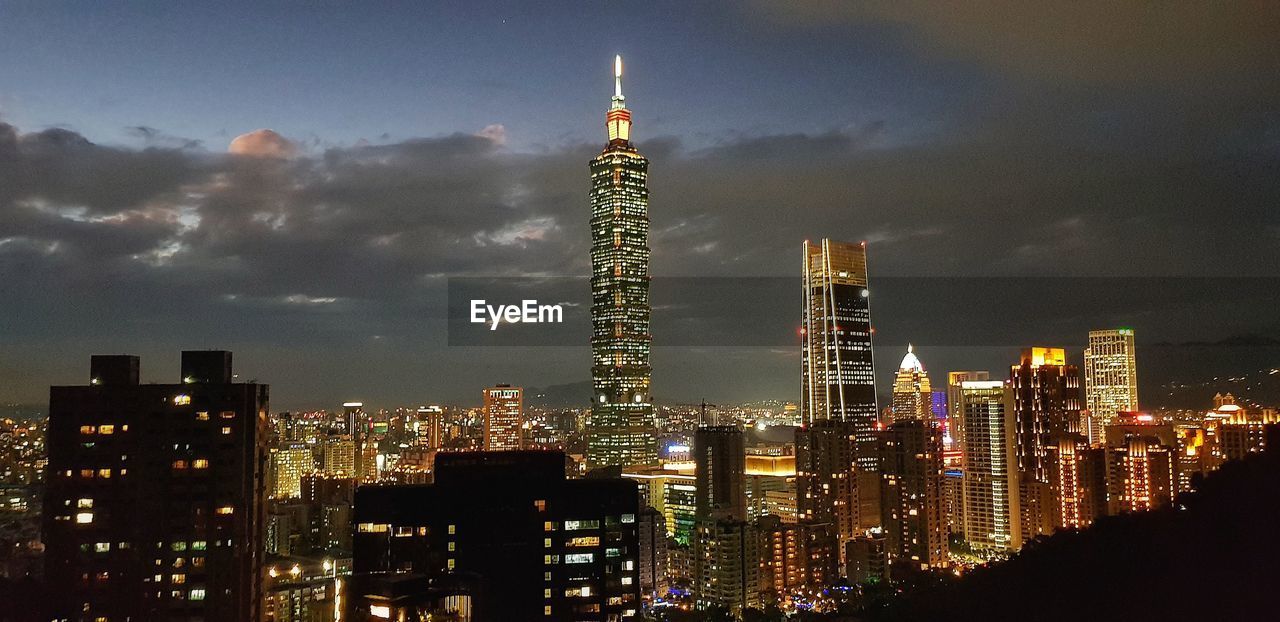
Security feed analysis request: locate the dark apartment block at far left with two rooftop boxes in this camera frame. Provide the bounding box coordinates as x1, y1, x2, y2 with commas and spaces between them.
44, 351, 269, 622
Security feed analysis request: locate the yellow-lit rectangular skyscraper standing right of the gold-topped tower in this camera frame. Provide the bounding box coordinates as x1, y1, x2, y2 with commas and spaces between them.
1084, 329, 1138, 444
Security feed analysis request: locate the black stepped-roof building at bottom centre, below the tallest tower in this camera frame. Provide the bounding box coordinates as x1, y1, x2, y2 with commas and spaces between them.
347, 451, 640, 622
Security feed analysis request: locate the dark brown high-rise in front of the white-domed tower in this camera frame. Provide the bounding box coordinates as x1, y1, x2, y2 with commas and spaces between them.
881, 416, 948, 570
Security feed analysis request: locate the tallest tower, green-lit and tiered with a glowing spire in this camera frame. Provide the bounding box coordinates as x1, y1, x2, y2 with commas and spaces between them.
586, 56, 658, 468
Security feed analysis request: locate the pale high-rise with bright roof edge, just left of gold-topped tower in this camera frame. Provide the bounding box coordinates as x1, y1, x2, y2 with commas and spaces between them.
957, 380, 1023, 553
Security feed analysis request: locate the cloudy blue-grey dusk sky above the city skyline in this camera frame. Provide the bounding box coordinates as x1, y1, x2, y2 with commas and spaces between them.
0, 0, 1280, 410
